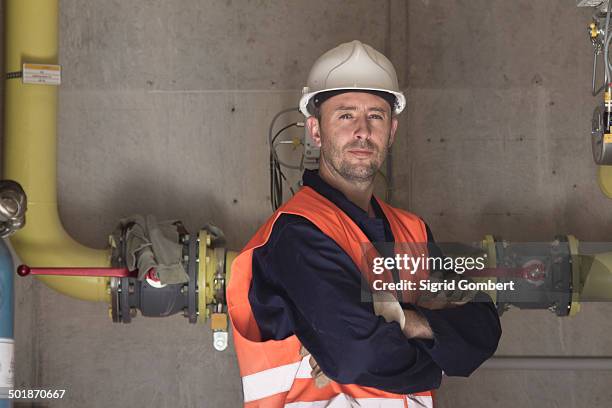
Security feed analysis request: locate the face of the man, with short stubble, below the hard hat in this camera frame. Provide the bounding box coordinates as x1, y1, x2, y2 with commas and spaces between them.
308, 92, 397, 182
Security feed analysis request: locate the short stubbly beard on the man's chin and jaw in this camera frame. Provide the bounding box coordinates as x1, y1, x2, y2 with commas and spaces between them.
321, 139, 387, 182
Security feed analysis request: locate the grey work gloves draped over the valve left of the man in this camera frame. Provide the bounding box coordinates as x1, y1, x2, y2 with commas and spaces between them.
111, 215, 189, 284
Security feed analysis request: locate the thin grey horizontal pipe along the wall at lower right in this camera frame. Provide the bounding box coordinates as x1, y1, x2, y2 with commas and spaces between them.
480, 357, 612, 371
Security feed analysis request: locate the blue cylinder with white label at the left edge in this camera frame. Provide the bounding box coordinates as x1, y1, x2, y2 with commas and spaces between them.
0, 239, 15, 408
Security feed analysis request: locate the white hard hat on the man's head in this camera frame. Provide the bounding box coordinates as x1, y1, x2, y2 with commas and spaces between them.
300, 40, 406, 117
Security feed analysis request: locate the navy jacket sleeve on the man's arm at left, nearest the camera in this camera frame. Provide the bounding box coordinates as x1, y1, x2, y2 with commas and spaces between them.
249, 216, 442, 394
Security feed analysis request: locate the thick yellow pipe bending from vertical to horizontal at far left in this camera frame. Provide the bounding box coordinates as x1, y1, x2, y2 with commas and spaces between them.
3, 0, 110, 301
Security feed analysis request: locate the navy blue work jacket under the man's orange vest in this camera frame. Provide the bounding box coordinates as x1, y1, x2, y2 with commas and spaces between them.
249, 170, 501, 394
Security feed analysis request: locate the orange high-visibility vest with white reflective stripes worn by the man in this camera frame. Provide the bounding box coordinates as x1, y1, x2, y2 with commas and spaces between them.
227, 187, 433, 408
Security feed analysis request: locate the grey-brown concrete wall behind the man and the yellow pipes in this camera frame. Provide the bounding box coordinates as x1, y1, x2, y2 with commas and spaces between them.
4, 0, 612, 408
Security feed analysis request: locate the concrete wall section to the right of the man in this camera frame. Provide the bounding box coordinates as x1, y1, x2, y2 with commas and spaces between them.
396, 0, 612, 408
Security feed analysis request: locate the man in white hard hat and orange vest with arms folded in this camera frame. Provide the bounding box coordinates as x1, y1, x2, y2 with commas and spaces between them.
227, 41, 501, 408
